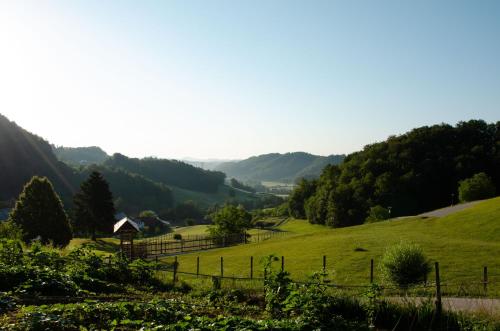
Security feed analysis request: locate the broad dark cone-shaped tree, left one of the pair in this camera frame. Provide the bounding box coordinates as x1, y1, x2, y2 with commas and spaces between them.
9, 177, 72, 246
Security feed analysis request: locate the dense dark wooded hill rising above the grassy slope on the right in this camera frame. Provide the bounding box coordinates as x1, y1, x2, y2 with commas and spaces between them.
290, 120, 500, 230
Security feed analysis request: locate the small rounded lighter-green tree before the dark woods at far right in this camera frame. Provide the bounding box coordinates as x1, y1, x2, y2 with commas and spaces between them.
458, 172, 495, 202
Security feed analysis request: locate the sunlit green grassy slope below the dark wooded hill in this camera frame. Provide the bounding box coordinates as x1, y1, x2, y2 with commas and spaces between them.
167, 198, 500, 291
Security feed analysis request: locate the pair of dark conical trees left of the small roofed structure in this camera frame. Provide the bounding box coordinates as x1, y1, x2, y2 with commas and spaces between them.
4, 172, 115, 247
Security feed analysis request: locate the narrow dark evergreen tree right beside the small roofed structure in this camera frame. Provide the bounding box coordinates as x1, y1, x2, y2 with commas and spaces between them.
74, 171, 115, 240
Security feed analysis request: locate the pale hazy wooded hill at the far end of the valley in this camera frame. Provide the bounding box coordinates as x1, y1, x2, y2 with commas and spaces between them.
216, 152, 345, 183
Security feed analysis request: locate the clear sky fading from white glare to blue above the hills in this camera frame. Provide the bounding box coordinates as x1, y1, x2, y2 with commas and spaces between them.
0, 0, 500, 158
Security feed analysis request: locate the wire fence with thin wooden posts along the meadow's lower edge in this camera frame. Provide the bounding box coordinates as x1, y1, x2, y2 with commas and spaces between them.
149, 257, 500, 298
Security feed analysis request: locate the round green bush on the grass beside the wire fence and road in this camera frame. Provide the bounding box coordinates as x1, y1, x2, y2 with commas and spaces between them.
381, 242, 431, 287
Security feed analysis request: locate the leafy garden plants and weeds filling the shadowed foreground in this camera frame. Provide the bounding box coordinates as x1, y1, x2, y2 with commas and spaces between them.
0, 240, 500, 330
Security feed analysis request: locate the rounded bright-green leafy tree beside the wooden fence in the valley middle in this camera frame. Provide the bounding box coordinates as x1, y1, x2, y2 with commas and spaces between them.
208, 205, 252, 237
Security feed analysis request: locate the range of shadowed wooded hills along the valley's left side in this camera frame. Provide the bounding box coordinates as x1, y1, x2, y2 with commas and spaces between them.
0, 115, 259, 215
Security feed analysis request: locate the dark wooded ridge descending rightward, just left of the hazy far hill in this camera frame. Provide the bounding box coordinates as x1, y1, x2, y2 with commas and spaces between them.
104, 154, 226, 193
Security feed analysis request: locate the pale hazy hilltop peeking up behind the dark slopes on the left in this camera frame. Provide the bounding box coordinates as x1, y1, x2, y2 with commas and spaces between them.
53, 146, 109, 166
